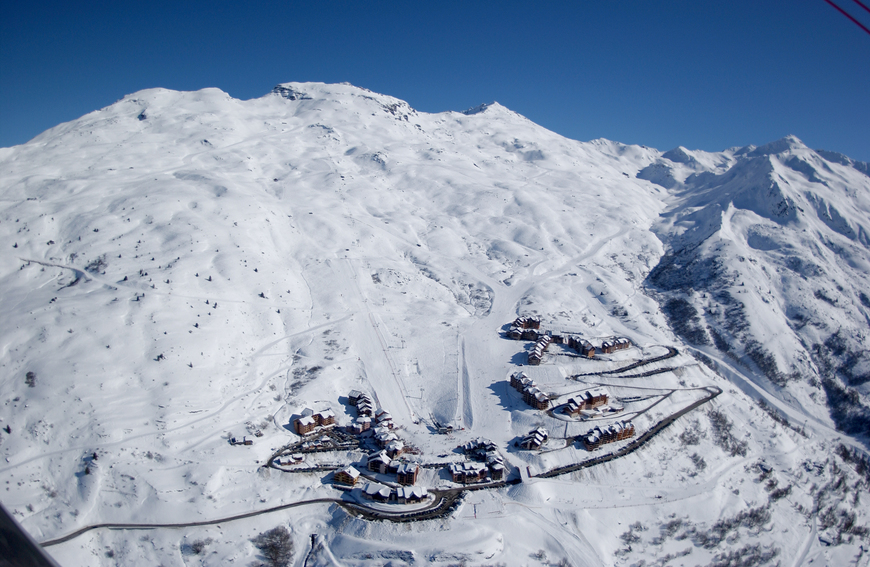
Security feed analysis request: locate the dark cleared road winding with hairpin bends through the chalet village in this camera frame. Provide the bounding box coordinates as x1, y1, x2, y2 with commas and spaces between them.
40, 347, 722, 547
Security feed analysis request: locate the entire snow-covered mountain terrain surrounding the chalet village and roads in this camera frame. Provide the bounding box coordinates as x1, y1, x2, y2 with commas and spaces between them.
0, 83, 870, 565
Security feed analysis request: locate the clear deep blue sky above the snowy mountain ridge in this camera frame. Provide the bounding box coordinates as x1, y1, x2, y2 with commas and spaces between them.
0, 0, 870, 161
